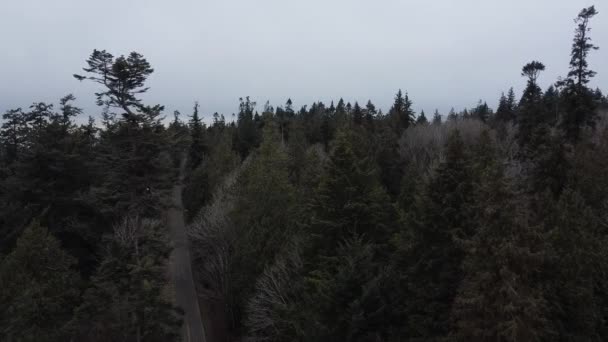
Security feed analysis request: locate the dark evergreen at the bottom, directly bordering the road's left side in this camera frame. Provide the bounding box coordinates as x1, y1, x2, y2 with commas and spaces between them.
70, 217, 181, 341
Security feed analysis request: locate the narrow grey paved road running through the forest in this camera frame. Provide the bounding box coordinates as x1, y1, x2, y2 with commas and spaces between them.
167, 156, 206, 342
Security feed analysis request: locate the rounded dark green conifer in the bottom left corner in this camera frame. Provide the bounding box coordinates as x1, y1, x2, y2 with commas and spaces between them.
0, 222, 79, 341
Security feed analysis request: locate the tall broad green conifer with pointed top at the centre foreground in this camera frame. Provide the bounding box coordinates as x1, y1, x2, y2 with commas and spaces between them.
302, 131, 396, 341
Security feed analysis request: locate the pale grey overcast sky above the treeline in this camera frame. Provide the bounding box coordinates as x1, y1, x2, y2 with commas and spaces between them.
0, 0, 608, 123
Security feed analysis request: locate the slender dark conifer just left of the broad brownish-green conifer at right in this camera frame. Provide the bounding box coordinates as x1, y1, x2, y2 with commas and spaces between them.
400, 130, 474, 341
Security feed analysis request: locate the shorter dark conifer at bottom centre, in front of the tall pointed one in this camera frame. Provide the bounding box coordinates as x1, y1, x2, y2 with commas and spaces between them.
299, 233, 391, 341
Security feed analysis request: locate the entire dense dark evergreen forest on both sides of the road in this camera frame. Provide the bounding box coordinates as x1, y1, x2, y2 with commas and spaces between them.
0, 7, 608, 342
